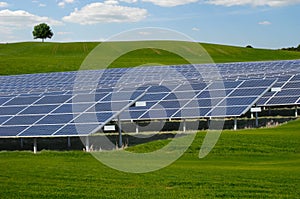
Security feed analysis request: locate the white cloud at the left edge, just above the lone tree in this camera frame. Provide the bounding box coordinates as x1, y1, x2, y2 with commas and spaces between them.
0, 9, 63, 28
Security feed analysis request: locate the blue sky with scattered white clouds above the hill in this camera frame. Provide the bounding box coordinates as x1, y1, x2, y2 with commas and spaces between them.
0, 0, 300, 49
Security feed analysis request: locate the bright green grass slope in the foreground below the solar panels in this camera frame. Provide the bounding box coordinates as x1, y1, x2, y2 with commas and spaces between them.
0, 120, 300, 198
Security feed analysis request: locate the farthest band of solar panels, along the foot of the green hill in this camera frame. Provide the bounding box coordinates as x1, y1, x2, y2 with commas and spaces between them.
0, 60, 300, 92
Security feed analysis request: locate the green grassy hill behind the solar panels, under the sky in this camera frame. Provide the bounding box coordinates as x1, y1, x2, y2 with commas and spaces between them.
0, 42, 300, 75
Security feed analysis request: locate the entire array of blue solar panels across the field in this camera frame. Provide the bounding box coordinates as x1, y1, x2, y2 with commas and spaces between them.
0, 60, 300, 137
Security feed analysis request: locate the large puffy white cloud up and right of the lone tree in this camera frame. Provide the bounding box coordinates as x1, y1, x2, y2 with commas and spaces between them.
63, 1, 148, 25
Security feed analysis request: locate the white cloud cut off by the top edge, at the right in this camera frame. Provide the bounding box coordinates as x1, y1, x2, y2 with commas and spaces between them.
206, 0, 300, 7
